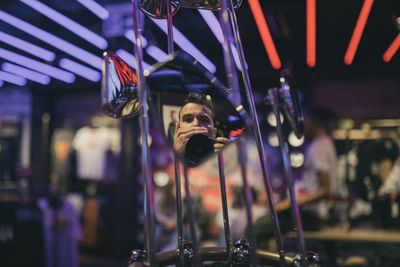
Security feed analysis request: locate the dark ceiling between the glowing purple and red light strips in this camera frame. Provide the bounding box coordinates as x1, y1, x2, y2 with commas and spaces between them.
0, 0, 400, 110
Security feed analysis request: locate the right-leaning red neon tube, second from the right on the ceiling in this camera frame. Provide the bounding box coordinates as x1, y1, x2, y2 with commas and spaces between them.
344, 0, 374, 65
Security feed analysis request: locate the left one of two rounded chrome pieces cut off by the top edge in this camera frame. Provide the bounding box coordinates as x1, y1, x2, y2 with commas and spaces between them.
138, 0, 179, 19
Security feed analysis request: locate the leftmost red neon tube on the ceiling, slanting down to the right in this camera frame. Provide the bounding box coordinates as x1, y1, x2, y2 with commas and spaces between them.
249, 0, 282, 69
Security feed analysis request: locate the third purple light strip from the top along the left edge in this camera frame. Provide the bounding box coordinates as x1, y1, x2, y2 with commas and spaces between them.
0, 48, 75, 83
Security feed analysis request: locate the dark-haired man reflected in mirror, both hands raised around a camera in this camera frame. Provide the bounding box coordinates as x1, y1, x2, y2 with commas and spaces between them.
174, 92, 230, 162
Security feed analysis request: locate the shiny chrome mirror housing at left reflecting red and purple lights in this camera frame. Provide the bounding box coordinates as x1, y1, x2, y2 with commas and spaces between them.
101, 51, 139, 118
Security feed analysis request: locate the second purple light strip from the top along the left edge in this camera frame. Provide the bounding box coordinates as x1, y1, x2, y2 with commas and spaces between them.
0, 31, 56, 62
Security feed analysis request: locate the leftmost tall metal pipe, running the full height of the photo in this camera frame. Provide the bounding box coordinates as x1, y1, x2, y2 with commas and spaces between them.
133, 0, 157, 266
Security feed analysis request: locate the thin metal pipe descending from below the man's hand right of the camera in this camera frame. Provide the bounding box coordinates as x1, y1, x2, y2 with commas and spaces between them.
218, 151, 232, 266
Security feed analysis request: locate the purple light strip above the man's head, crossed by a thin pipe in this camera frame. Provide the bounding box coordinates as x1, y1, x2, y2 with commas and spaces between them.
151, 18, 217, 73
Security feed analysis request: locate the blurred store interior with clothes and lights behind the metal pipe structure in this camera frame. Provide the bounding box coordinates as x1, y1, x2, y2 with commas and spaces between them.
0, 0, 400, 267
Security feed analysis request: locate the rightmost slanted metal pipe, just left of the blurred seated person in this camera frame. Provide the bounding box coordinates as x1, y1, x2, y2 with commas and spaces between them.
268, 88, 306, 266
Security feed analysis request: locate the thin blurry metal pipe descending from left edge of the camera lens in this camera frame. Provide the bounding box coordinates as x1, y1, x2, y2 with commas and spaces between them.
183, 165, 200, 267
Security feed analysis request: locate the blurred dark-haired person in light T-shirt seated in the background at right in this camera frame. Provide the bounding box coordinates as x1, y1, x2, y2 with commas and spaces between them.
255, 107, 337, 248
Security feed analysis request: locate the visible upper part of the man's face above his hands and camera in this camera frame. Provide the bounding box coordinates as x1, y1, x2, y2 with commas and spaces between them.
179, 103, 217, 138
